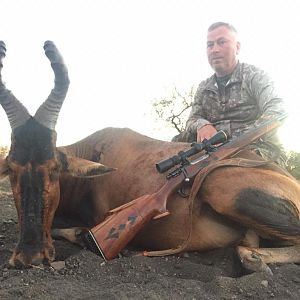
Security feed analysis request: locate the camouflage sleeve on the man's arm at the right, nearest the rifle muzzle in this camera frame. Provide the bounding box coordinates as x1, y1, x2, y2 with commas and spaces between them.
249, 70, 286, 123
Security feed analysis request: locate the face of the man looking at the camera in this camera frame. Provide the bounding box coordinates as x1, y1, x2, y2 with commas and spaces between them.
207, 26, 240, 77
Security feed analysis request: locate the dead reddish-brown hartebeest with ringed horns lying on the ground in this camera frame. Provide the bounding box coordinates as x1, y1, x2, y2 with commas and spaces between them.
0, 42, 300, 272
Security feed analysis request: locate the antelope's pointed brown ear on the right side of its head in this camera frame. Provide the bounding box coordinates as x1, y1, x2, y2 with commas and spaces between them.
63, 155, 116, 178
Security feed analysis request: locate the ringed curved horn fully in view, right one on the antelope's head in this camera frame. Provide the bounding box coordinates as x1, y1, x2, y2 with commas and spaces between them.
34, 41, 70, 130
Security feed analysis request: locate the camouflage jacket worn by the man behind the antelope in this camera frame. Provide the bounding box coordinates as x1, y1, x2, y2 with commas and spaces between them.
186, 63, 285, 168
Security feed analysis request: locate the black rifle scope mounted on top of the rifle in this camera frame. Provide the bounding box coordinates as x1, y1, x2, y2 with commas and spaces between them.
155, 130, 229, 173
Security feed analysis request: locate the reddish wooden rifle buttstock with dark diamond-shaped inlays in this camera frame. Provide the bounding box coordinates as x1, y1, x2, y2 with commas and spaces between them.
83, 178, 182, 260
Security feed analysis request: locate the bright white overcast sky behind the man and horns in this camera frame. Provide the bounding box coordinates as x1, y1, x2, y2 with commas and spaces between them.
0, 0, 300, 151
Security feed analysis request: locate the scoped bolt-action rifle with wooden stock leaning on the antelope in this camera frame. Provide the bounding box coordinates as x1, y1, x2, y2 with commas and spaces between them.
83, 114, 286, 260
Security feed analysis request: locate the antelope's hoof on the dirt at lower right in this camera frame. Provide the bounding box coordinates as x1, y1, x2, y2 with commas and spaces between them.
238, 247, 273, 275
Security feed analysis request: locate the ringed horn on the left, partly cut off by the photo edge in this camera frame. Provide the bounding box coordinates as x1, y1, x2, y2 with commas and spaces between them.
0, 41, 30, 130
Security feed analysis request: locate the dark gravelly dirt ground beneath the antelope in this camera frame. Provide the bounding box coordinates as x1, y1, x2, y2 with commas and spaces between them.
0, 180, 300, 300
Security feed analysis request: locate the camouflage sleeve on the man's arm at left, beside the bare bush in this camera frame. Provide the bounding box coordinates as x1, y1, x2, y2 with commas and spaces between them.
186, 83, 210, 132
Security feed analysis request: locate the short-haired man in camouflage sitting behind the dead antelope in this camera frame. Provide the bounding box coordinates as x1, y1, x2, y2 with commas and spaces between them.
177, 22, 286, 166
